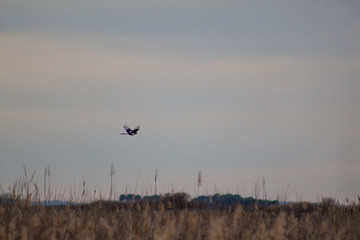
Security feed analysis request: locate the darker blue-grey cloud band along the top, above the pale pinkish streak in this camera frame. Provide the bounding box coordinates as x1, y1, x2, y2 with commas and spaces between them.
0, 1, 360, 55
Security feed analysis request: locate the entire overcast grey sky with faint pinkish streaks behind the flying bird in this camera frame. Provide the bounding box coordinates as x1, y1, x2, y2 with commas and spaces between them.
0, 0, 360, 202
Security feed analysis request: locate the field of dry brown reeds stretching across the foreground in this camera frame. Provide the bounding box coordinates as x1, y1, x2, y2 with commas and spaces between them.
0, 201, 360, 240
